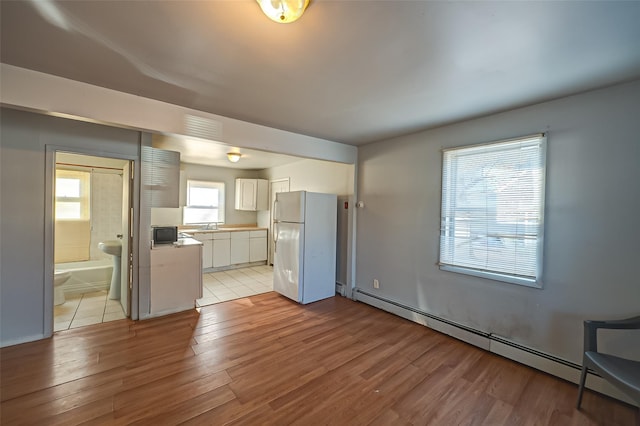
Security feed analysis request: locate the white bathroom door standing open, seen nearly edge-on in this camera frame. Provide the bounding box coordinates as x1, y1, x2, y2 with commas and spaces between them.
120, 161, 133, 317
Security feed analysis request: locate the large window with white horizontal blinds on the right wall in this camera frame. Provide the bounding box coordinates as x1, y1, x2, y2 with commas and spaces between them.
440, 134, 546, 287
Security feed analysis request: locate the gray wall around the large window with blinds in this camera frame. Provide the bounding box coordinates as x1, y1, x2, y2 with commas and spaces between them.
356, 81, 640, 362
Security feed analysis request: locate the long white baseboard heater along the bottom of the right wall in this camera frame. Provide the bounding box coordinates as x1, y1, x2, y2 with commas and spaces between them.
353, 287, 638, 406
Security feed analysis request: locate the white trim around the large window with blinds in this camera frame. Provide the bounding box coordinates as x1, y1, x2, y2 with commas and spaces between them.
438, 133, 547, 288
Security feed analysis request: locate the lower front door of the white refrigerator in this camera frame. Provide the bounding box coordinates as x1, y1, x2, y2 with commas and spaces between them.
273, 222, 304, 302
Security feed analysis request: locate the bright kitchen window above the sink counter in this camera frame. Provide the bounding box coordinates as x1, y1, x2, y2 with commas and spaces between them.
182, 180, 225, 225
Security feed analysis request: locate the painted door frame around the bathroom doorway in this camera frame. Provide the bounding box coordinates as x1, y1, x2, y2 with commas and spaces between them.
43, 144, 140, 338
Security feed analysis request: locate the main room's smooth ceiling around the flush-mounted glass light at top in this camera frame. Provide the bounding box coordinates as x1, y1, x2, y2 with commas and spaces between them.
0, 0, 640, 145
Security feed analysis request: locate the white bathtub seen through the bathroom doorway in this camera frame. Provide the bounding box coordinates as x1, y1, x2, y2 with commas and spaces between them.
56, 259, 113, 295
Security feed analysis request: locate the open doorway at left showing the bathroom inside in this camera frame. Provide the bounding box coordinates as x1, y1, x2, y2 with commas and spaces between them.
53, 152, 132, 331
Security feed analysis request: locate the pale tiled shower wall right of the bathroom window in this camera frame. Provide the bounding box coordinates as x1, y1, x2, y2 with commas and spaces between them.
89, 171, 122, 260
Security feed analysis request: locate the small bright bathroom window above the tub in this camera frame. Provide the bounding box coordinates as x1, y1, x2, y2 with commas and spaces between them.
55, 169, 91, 221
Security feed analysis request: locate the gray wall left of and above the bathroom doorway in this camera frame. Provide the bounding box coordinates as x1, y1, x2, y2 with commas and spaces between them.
0, 108, 140, 346
